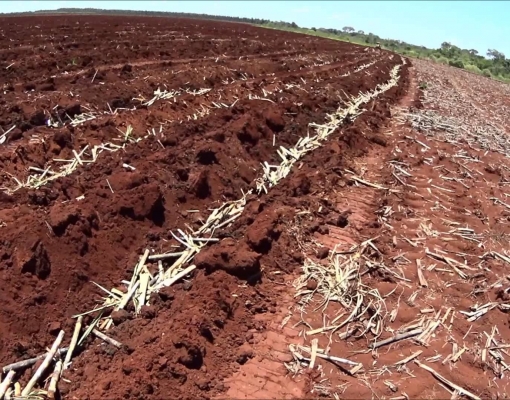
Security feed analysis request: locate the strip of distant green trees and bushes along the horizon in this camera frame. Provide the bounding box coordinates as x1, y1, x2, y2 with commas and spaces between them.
4, 8, 510, 82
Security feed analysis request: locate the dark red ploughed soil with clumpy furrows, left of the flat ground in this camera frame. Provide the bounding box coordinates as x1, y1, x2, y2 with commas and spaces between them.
0, 16, 408, 399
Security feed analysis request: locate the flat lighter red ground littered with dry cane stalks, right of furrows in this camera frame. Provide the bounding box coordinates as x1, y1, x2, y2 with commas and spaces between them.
274, 60, 510, 399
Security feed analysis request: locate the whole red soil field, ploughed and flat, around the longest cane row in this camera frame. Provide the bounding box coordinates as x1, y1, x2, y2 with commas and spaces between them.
0, 11, 510, 399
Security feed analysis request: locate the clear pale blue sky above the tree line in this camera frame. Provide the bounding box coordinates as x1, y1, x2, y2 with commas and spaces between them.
1, 0, 510, 57
